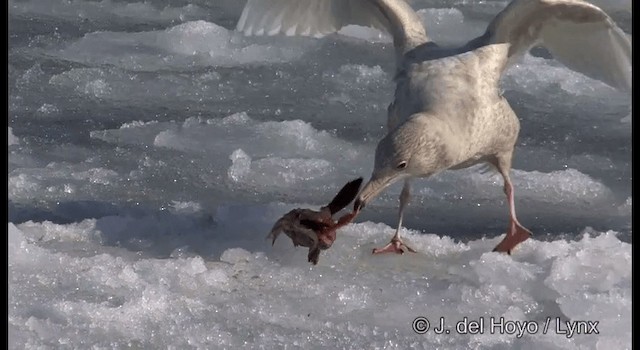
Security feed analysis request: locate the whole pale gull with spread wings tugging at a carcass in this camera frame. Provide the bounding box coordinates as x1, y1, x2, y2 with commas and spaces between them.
237, 0, 632, 252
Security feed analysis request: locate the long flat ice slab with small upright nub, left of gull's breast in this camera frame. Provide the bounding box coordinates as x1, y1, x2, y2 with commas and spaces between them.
91, 113, 368, 175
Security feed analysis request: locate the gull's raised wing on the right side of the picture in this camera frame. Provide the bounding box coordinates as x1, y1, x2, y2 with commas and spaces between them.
467, 0, 631, 90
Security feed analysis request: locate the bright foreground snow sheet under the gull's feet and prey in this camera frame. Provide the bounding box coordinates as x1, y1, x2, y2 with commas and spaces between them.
9, 219, 631, 349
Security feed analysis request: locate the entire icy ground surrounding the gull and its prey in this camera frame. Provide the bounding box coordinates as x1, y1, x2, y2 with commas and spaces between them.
7, 0, 632, 350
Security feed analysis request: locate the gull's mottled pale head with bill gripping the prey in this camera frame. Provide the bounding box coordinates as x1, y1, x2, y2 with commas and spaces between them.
354, 118, 442, 211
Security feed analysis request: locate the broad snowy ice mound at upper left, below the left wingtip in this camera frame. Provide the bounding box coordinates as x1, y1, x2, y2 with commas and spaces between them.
52, 21, 311, 71
